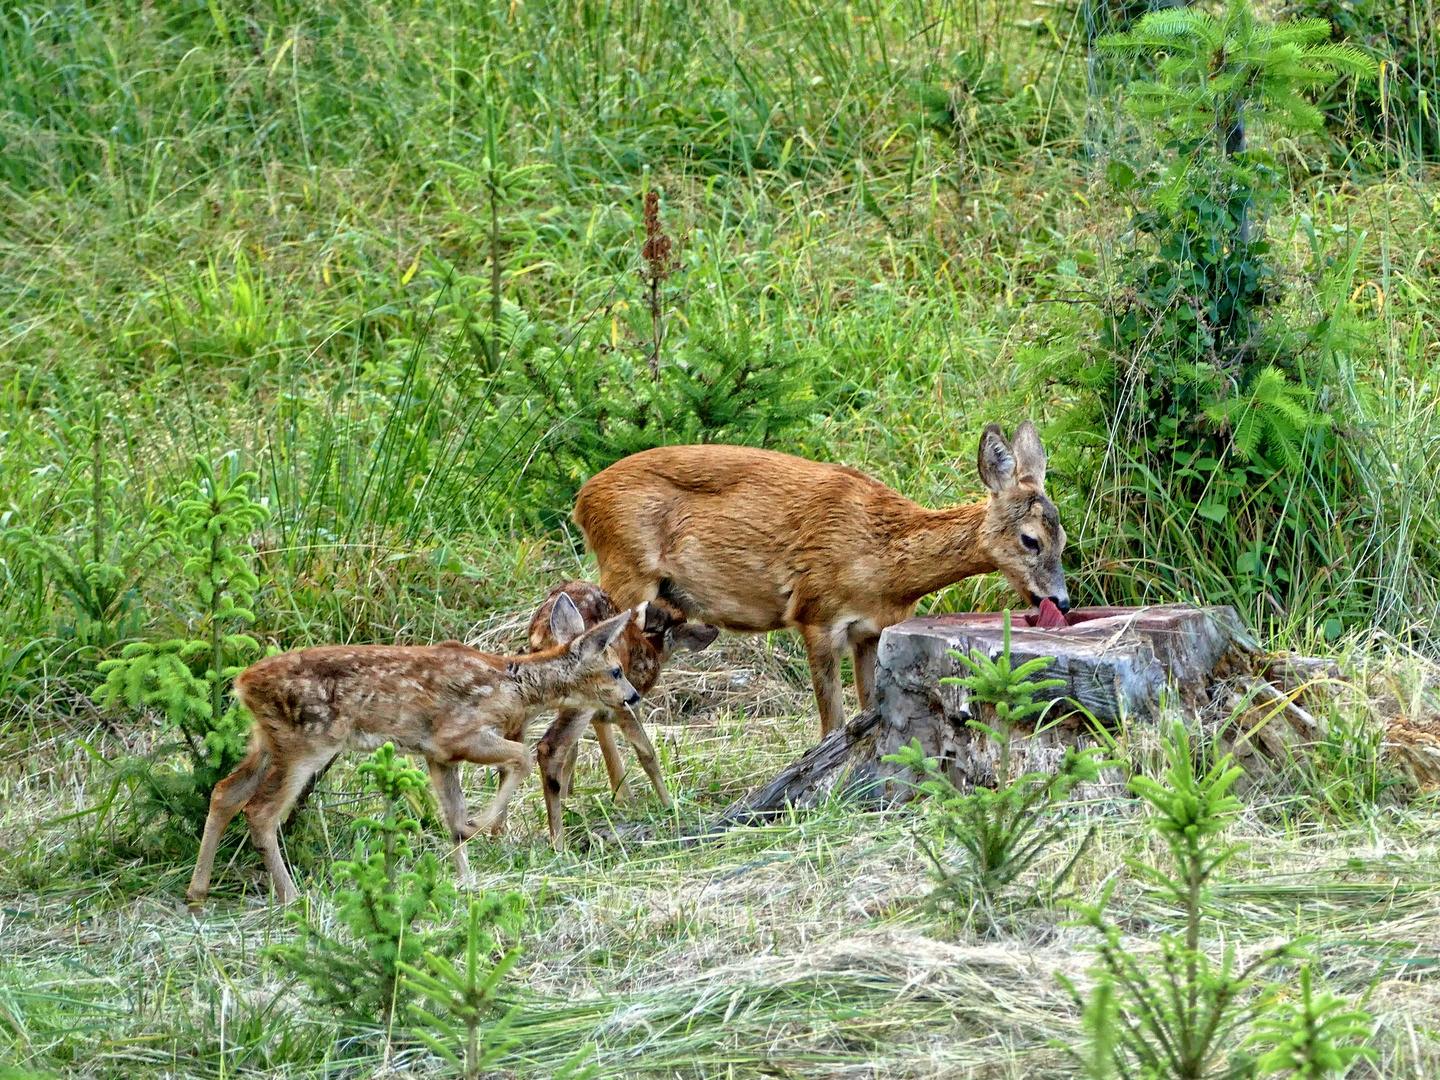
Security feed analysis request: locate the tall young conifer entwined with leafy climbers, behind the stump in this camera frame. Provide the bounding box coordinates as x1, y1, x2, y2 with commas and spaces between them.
1050, 0, 1374, 629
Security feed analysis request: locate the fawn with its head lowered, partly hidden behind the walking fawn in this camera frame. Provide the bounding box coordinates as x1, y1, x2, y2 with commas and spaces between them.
530, 582, 720, 848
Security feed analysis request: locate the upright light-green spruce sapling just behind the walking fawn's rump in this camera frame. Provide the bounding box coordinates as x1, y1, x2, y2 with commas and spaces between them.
99, 456, 269, 825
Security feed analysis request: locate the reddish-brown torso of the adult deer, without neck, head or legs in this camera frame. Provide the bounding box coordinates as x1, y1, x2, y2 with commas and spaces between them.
575, 445, 924, 631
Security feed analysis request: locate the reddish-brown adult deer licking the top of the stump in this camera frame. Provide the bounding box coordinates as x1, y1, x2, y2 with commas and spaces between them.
575, 420, 1070, 734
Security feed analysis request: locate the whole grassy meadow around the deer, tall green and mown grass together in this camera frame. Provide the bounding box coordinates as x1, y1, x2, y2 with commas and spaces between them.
0, 0, 1440, 1079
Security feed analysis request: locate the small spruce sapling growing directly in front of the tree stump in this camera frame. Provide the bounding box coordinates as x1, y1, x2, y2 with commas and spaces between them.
884, 609, 1104, 926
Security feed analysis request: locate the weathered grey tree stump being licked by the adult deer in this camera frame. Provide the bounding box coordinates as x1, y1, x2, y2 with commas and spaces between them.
716, 603, 1267, 825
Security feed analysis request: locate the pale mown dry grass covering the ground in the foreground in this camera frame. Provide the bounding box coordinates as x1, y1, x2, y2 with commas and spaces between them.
8, 622, 1440, 1077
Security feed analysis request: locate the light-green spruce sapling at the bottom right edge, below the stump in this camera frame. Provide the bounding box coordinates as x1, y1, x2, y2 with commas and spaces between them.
1061, 723, 1368, 1080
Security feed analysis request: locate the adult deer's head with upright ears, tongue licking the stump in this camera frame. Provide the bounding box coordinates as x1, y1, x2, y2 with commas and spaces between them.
978, 420, 1070, 611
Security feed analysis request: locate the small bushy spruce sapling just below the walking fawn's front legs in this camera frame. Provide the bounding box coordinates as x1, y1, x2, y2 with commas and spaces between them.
268, 743, 455, 1024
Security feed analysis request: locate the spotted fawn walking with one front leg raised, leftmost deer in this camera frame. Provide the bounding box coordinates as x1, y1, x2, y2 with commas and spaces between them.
186, 596, 645, 904
